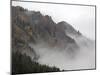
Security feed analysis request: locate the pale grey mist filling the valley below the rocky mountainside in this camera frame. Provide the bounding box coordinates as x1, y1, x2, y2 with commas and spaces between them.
30, 35, 95, 70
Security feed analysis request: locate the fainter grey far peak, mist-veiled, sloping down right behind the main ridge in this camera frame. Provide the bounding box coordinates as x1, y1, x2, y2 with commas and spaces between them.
58, 21, 94, 47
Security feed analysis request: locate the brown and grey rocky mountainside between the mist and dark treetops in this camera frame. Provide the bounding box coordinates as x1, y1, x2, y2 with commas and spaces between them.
12, 6, 81, 60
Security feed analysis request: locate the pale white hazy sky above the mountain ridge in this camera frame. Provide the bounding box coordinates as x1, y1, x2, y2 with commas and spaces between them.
12, 1, 95, 40
